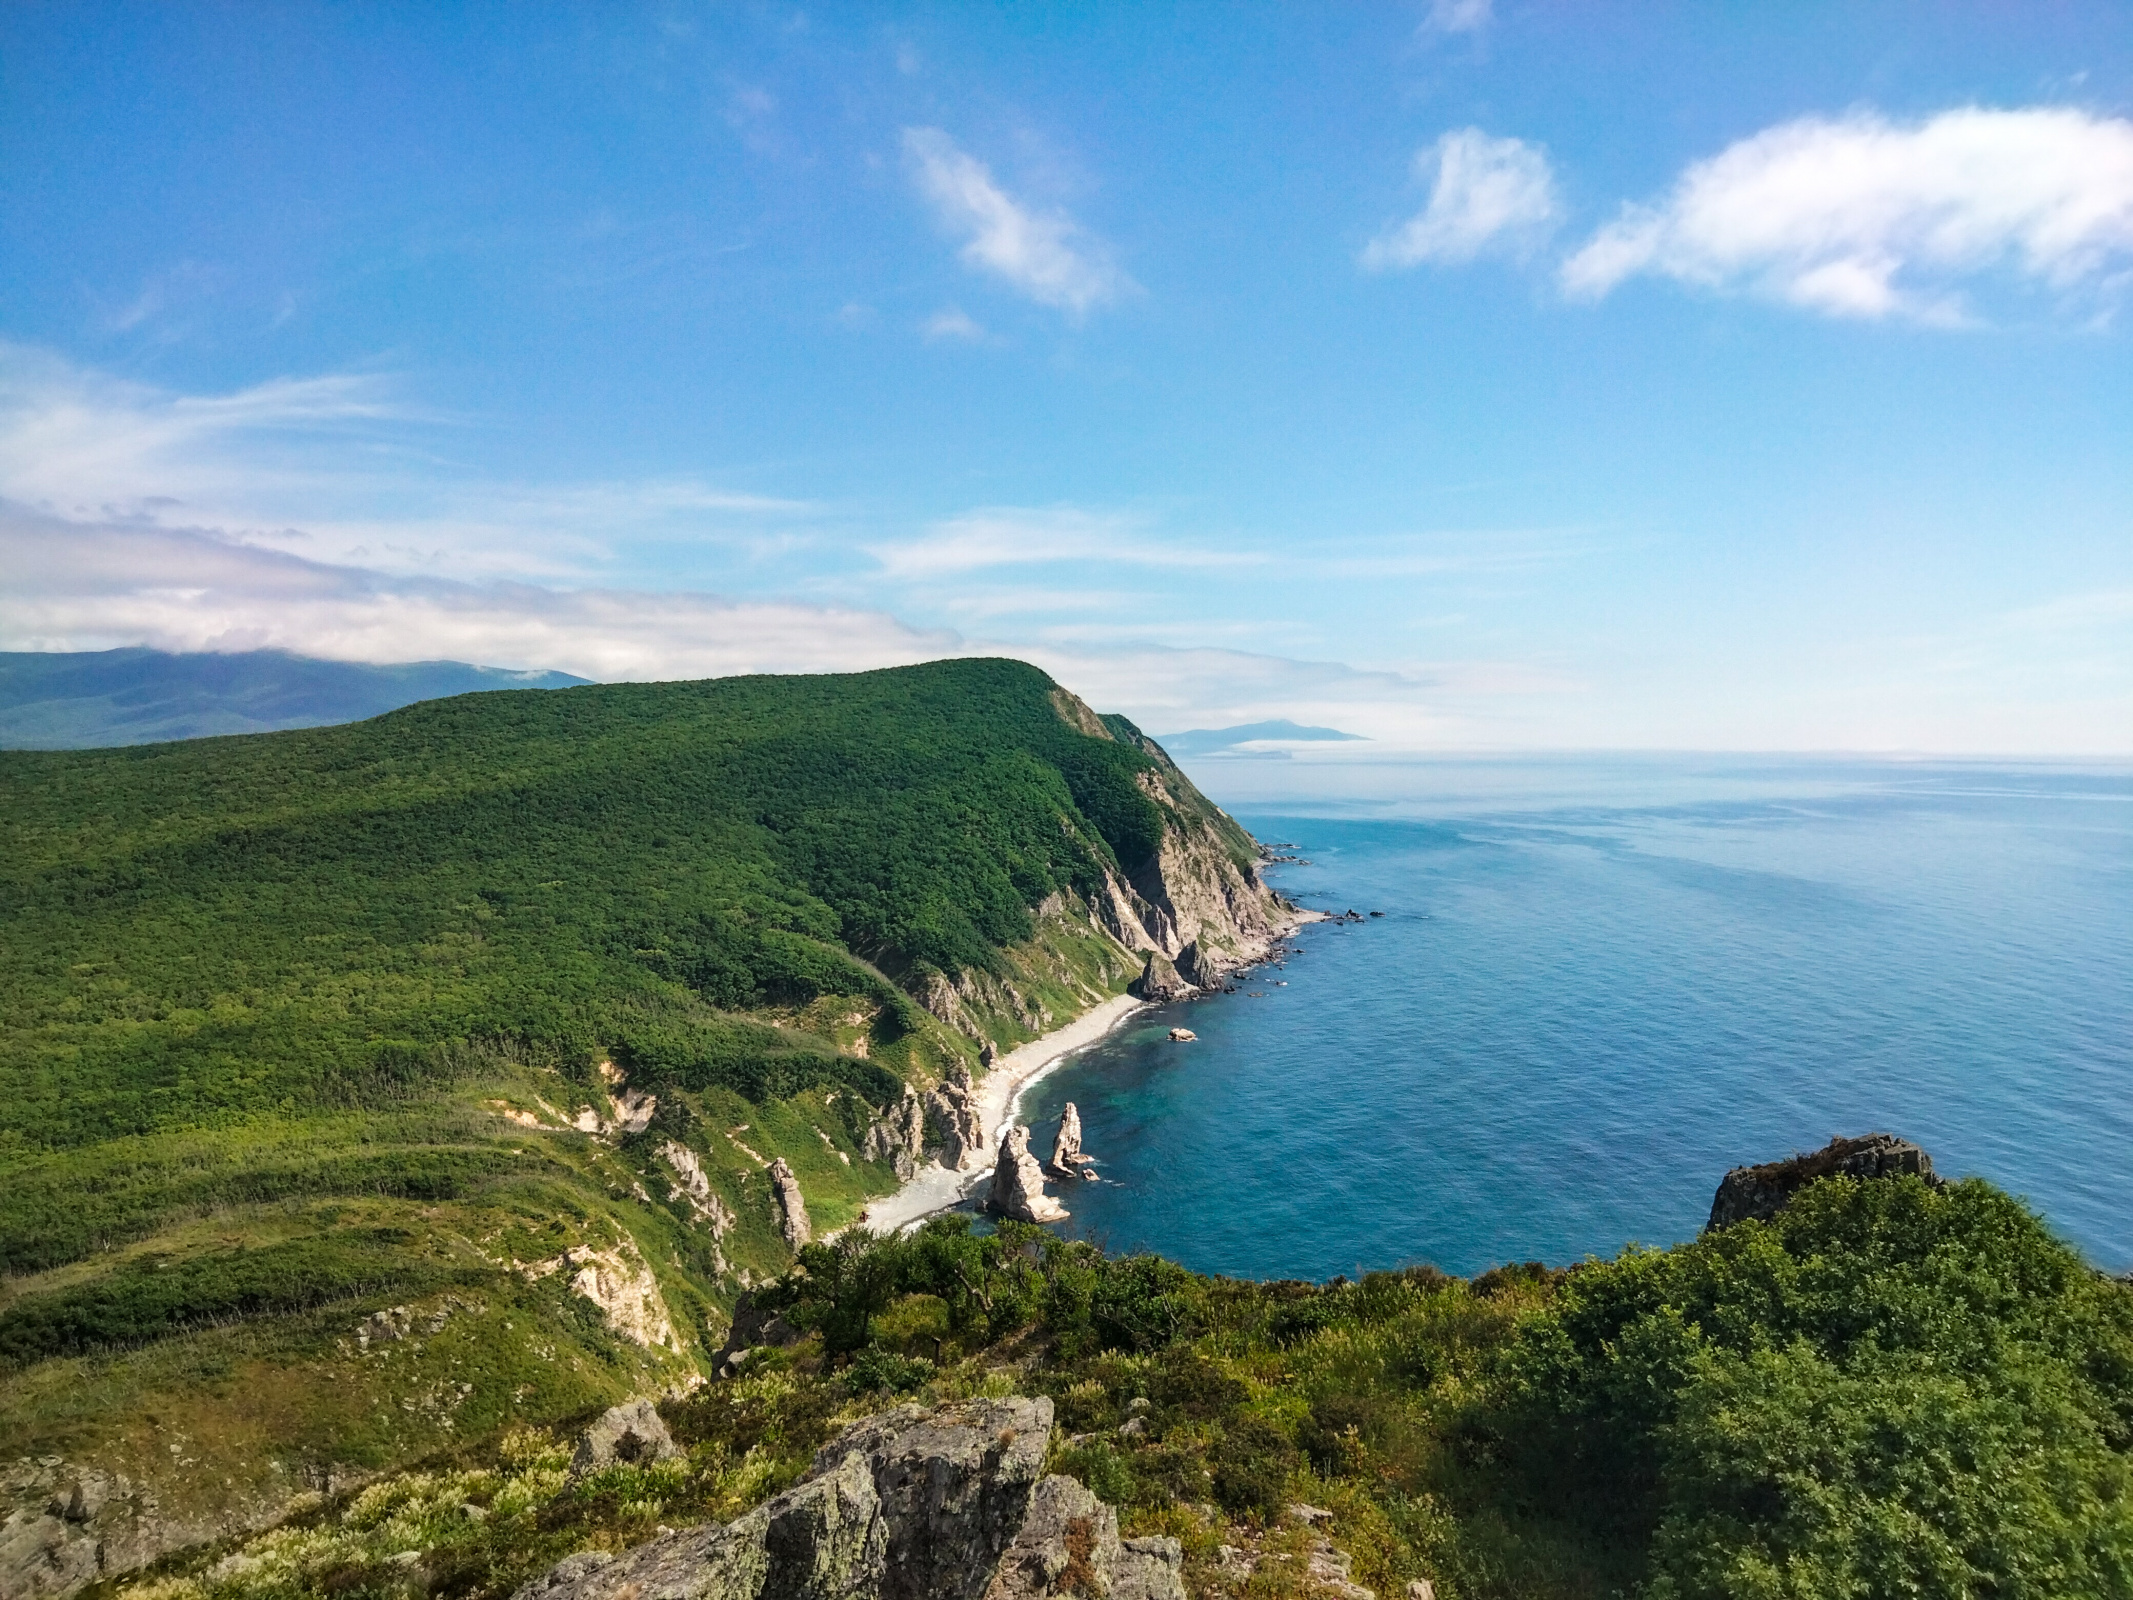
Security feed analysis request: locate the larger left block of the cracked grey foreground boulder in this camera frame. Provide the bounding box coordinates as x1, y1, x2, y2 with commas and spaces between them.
518, 1397, 1049, 1600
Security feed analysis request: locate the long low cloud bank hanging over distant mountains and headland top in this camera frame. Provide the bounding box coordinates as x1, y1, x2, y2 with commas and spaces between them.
0, 501, 1484, 738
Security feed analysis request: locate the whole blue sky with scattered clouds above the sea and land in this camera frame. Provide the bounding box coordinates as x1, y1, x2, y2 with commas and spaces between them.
0, 0, 2133, 759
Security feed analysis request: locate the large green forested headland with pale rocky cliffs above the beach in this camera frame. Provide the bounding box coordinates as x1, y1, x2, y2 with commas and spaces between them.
0, 661, 1286, 1591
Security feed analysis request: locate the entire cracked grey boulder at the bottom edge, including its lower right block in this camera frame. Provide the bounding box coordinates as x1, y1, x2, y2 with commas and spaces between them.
518, 1395, 1186, 1600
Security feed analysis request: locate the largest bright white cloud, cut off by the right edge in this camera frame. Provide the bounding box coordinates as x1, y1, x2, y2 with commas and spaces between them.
1561, 107, 2133, 322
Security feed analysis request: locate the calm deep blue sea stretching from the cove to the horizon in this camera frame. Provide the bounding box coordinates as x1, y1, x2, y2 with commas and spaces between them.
1022, 759, 2133, 1278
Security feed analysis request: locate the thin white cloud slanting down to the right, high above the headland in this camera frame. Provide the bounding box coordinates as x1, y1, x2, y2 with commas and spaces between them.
904, 128, 1133, 316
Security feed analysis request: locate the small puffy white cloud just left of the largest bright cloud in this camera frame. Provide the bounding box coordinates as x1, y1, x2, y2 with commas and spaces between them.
1363, 128, 1559, 269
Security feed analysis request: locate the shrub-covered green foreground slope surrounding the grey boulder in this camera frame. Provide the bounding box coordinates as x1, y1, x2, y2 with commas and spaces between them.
112, 1178, 2133, 1600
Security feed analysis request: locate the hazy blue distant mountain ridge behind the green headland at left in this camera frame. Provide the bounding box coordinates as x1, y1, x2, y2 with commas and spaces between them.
0, 649, 584, 751
